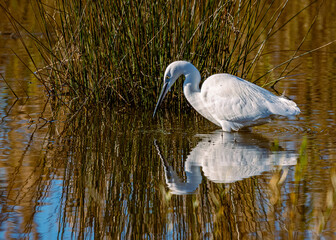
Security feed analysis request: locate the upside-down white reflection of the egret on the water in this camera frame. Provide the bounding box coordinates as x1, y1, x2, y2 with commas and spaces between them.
154, 130, 297, 195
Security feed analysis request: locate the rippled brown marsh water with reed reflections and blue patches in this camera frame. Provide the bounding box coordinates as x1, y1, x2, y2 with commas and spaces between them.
0, 1, 336, 239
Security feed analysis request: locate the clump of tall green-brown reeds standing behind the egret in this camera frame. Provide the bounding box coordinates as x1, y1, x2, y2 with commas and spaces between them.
0, 0, 320, 110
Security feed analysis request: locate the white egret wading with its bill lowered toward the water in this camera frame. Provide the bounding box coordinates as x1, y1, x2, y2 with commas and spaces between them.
153, 61, 300, 132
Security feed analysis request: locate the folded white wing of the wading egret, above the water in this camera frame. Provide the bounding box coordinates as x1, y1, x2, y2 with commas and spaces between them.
201, 74, 279, 123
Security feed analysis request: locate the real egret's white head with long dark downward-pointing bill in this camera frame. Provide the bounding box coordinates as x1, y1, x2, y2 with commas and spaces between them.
153, 61, 186, 117
